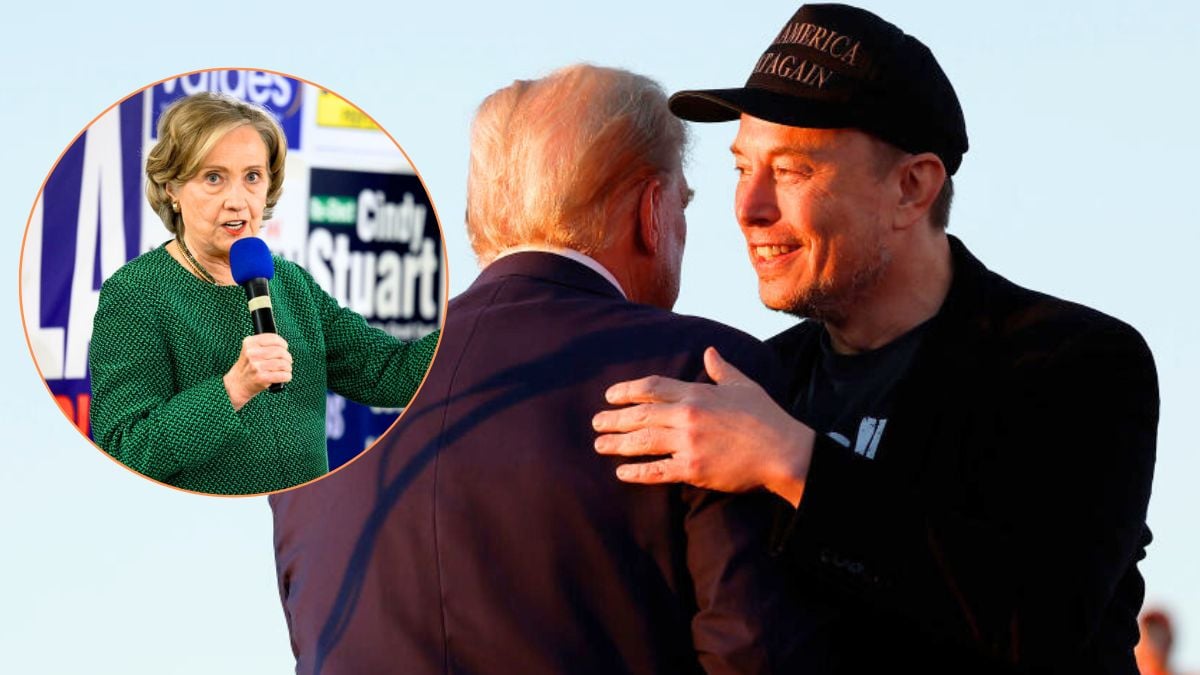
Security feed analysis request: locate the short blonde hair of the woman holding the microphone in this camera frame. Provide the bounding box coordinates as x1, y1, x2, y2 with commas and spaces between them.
146, 91, 288, 234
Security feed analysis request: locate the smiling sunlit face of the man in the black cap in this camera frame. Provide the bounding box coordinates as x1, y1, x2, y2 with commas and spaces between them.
731, 115, 898, 323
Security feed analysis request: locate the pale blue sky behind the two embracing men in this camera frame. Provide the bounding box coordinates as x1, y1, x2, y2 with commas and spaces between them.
0, 0, 1200, 674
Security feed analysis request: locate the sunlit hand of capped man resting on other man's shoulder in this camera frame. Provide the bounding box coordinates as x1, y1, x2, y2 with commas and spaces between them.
592, 347, 815, 506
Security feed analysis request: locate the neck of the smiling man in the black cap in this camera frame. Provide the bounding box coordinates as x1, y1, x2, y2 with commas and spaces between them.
826, 234, 954, 354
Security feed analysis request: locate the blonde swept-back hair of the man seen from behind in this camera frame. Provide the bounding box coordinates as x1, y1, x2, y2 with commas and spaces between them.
467, 64, 686, 265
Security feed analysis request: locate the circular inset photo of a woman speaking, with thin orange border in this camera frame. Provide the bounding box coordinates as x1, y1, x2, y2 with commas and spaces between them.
20, 70, 446, 495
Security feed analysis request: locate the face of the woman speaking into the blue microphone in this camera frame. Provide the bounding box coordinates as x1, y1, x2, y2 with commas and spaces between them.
168, 125, 270, 262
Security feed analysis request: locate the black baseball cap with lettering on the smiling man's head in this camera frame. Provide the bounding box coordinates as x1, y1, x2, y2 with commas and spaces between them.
668, 5, 967, 174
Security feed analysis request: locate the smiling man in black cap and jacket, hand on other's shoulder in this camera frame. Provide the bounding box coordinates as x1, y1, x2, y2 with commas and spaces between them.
594, 5, 1158, 674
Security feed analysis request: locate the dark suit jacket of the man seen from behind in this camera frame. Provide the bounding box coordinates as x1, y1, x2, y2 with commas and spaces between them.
271, 252, 803, 674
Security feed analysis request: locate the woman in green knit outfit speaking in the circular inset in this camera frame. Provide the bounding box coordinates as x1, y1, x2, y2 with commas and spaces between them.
89, 92, 438, 495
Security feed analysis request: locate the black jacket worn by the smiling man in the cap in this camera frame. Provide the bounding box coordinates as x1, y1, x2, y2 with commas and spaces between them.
772, 238, 1158, 675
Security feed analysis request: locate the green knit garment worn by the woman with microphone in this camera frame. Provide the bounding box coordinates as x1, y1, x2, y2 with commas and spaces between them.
89, 247, 439, 495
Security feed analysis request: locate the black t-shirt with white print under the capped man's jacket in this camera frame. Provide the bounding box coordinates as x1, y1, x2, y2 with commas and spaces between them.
792, 323, 928, 459
